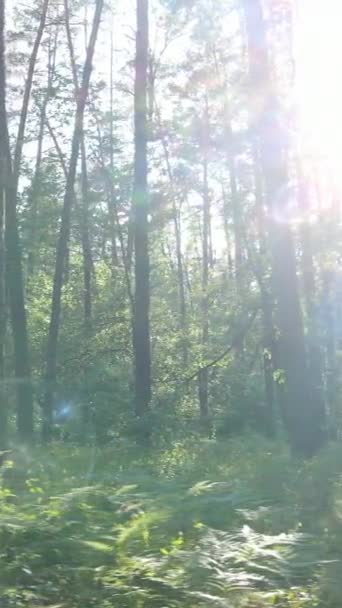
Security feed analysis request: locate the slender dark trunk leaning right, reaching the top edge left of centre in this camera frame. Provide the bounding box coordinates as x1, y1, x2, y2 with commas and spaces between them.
42, 0, 103, 442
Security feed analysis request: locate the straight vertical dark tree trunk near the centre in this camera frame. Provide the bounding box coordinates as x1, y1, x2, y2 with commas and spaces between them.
133, 0, 151, 417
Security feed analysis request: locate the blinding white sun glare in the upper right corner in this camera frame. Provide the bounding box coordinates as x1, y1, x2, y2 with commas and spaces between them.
295, 0, 342, 188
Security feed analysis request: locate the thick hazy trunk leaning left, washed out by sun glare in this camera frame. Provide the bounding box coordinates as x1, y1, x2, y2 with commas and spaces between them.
243, 0, 324, 456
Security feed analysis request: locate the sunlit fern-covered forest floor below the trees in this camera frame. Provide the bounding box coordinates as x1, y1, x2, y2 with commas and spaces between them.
0, 437, 342, 608
